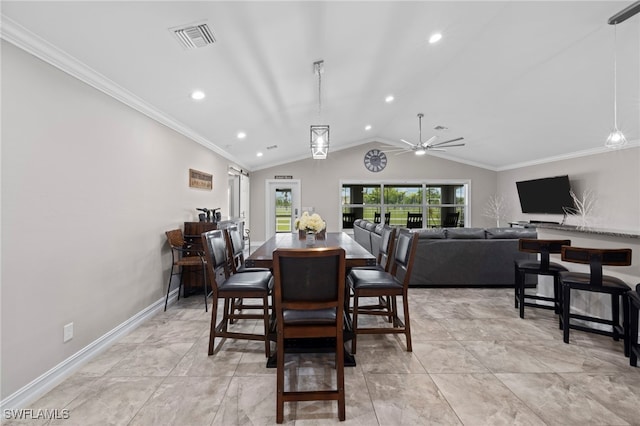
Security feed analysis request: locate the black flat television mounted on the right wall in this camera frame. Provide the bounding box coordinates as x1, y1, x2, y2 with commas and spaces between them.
516, 175, 575, 214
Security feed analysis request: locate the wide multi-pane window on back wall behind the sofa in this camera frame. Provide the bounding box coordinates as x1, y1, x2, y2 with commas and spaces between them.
342, 182, 469, 229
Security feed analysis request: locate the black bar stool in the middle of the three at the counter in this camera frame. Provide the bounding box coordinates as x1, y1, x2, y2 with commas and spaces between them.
560, 246, 631, 355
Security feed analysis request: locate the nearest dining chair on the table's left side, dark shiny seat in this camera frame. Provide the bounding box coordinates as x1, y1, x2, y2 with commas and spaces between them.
202, 230, 273, 357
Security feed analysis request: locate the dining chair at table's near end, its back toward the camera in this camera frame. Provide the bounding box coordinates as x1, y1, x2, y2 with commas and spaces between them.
273, 247, 346, 423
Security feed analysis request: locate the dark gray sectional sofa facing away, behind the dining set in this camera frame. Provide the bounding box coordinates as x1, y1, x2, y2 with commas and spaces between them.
353, 219, 537, 287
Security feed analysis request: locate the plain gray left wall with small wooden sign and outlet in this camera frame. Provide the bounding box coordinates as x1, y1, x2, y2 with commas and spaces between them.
1, 42, 228, 399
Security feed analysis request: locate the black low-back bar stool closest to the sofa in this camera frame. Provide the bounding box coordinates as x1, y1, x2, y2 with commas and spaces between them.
514, 238, 571, 318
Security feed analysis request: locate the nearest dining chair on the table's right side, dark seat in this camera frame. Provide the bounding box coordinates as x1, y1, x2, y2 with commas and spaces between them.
347, 229, 418, 354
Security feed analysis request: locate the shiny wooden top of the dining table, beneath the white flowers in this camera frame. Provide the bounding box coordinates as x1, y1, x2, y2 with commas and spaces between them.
245, 232, 376, 268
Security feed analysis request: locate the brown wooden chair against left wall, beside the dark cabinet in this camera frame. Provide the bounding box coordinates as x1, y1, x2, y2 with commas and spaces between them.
164, 229, 208, 312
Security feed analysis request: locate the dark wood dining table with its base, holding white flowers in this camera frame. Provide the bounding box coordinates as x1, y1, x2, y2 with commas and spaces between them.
245, 232, 376, 368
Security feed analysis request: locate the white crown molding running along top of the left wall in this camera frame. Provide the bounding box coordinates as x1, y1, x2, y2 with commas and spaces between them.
0, 14, 247, 168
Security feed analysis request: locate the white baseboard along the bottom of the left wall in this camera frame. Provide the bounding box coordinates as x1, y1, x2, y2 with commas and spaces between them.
0, 289, 179, 412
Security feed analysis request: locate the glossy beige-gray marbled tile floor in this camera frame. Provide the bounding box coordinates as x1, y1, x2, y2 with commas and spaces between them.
6, 289, 640, 426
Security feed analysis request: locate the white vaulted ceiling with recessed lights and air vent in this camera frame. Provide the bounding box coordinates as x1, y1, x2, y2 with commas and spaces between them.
2, 1, 640, 170
